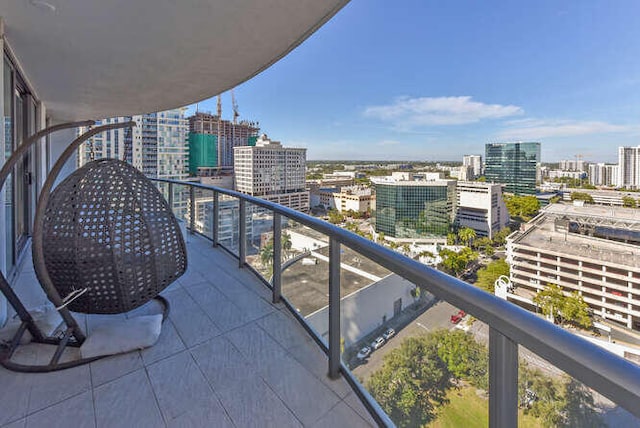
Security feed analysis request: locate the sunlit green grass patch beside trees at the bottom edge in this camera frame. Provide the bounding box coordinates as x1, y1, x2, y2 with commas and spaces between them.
428, 387, 541, 428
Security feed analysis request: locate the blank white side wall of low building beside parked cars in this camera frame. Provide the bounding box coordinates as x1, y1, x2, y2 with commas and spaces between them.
306, 274, 422, 347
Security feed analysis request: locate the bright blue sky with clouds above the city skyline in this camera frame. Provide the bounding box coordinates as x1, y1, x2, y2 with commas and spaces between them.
192, 0, 640, 162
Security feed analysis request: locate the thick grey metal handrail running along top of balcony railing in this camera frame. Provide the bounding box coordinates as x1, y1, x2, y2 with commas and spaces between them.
154, 179, 640, 420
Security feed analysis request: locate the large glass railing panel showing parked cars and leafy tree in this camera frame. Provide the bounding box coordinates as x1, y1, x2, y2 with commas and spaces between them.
341, 242, 489, 427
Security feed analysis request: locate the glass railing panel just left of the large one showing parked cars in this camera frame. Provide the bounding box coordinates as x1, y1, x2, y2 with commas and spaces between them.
282, 221, 329, 344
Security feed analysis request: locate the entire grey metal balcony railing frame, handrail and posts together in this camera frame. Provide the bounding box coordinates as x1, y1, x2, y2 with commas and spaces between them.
154, 179, 640, 427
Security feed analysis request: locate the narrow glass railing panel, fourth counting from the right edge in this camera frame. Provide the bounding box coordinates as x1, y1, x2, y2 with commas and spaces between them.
245, 202, 274, 282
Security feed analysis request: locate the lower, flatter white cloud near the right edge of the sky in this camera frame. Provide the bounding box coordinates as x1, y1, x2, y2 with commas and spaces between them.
498, 119, 633, 140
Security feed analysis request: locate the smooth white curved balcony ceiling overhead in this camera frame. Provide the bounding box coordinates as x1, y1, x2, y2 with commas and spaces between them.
0, 0, 348, 120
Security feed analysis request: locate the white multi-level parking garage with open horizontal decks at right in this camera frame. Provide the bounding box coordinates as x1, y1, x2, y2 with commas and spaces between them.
507, 204, 640, 330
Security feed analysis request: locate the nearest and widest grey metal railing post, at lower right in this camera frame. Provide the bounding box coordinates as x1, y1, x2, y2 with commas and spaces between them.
489, 327, 518, 428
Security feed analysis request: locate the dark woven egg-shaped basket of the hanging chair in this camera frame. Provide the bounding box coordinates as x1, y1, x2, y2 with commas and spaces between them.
36, 159, 187, 314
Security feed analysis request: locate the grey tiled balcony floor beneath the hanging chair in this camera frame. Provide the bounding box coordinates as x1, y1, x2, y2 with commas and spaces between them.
0, 236, 375, 428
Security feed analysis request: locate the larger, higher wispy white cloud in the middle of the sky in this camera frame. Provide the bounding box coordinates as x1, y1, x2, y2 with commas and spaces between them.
364, 96, 524, 130
